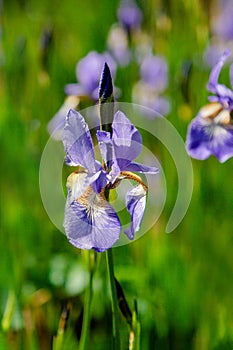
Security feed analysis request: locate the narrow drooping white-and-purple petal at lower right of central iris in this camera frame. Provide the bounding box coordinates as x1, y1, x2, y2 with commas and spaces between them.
125, 184, 147, 239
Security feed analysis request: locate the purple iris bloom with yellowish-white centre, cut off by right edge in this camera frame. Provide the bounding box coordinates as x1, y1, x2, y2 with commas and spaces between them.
186, 50, 233, 163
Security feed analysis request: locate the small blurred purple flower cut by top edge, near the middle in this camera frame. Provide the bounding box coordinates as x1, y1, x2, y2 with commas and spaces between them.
117, 0, 142, 31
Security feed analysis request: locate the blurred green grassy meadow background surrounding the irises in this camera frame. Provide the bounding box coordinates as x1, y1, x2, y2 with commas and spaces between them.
0, 0, 233, 350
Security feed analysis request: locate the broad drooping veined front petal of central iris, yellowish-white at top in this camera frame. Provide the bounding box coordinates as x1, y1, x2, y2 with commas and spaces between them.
64, 180, 121, 252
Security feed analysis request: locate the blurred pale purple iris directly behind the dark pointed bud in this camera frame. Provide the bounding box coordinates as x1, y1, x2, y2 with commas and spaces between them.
65, 51, 116, 101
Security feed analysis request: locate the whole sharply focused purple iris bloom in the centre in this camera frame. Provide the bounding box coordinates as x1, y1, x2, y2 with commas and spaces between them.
63, 109, 158, 252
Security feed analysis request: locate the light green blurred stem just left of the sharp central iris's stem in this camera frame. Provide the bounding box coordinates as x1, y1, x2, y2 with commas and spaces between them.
79, 251, 95, 350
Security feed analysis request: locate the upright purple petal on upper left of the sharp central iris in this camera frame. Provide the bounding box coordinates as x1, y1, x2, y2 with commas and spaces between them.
62, 109, 96, 173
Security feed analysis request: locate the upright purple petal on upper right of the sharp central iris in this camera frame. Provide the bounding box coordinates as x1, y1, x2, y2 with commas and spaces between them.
112, 111, 142, 170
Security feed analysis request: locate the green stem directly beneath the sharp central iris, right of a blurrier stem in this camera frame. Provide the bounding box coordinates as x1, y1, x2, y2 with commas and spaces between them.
106, 249, 120, 350
